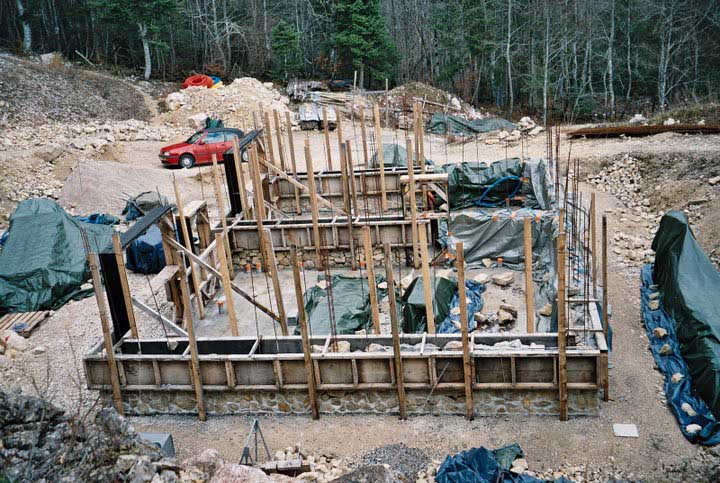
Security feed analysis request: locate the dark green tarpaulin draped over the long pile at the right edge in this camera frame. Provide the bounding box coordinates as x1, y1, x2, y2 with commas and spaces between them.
652, 211, 720, 417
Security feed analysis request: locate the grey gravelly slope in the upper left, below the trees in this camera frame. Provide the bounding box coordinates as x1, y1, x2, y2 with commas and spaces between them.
0, 54, 151, 130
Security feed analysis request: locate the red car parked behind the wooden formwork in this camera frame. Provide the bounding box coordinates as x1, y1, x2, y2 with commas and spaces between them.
160, 127, 244, 168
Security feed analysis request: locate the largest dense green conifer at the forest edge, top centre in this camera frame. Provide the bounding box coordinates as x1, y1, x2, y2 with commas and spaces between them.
333, 0, 396, 87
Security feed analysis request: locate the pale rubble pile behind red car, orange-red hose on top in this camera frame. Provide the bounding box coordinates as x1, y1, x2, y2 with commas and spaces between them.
161, 77, 290, 129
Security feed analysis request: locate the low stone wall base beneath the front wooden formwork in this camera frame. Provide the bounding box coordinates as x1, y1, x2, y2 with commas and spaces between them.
103, 390, 599, 416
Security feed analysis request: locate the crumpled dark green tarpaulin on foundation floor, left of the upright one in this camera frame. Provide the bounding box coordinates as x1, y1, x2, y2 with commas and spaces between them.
295, 275, 387, 335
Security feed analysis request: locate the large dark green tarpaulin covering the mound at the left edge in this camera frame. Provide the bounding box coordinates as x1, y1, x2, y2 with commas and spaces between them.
0, 199, 113, 313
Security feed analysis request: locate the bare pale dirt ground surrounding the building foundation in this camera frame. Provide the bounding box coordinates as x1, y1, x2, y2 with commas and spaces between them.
0, 67, 720, 481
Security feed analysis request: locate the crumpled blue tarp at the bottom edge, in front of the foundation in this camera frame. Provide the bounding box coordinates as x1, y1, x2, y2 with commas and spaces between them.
435, 443, 570, 483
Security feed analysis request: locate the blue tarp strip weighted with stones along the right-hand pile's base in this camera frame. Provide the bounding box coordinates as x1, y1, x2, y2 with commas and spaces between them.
640, 265, 720, 446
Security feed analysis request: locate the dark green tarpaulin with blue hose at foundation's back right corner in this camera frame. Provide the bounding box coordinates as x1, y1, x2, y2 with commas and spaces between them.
440, 158, 524, 210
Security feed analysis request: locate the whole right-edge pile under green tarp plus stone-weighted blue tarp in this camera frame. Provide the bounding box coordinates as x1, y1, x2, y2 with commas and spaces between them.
641, 211, 720, 445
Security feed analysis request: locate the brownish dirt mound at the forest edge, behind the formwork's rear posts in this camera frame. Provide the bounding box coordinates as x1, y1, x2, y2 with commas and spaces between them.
378, 82, 485, 119
